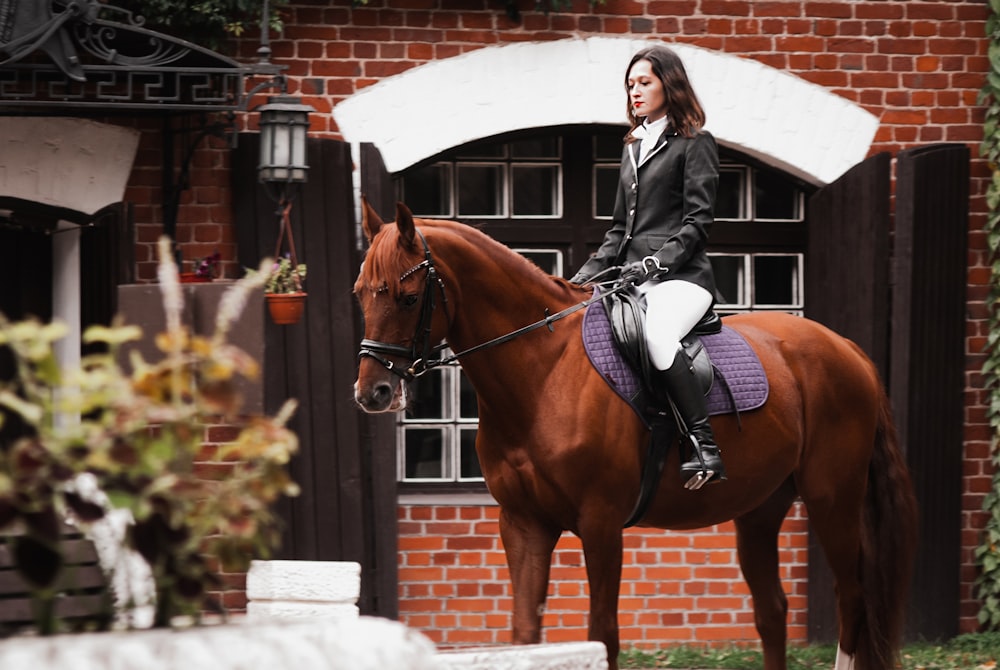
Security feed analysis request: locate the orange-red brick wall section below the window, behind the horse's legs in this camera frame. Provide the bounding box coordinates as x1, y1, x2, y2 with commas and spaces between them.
399, 504, 808, 647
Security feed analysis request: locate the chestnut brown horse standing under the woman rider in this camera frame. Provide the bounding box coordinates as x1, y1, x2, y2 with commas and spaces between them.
354, 203, 916, 670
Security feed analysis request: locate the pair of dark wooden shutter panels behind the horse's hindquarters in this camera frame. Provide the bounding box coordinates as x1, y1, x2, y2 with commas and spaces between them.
806, 145, 969, 641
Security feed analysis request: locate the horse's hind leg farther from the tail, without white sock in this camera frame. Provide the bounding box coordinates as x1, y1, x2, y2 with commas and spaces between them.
734, 479, 795, 670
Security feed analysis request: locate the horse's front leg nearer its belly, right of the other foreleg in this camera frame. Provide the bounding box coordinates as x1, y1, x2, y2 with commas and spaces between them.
580, 525, 622, 670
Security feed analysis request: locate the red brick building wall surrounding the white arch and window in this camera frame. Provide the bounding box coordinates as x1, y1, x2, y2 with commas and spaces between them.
117, 0, 992, 643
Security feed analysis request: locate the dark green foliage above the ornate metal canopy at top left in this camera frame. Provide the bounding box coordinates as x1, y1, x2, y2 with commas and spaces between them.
120, 0, 288, 49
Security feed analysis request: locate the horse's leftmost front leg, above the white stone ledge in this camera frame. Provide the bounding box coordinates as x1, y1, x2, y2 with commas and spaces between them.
500, 508, 561, 644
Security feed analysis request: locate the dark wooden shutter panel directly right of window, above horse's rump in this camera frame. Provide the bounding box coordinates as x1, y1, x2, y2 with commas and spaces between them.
805, 153, 890, 642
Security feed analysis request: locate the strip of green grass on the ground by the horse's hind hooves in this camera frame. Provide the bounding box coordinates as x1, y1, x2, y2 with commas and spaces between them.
619, 633, 1000, 670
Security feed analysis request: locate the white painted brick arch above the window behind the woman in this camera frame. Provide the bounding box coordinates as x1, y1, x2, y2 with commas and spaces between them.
333, 37, 879, 185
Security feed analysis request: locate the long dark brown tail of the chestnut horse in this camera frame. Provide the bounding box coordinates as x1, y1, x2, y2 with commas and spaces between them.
855, 391, 917, 670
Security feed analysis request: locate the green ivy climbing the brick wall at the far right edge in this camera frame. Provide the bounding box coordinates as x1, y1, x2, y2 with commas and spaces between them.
975, 0, 1000, 630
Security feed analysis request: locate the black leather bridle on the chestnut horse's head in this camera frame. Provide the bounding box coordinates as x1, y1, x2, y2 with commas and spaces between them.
358, 229, 448, 381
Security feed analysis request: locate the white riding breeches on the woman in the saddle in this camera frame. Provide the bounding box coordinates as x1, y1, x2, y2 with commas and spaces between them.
639, 279, 712, 370
